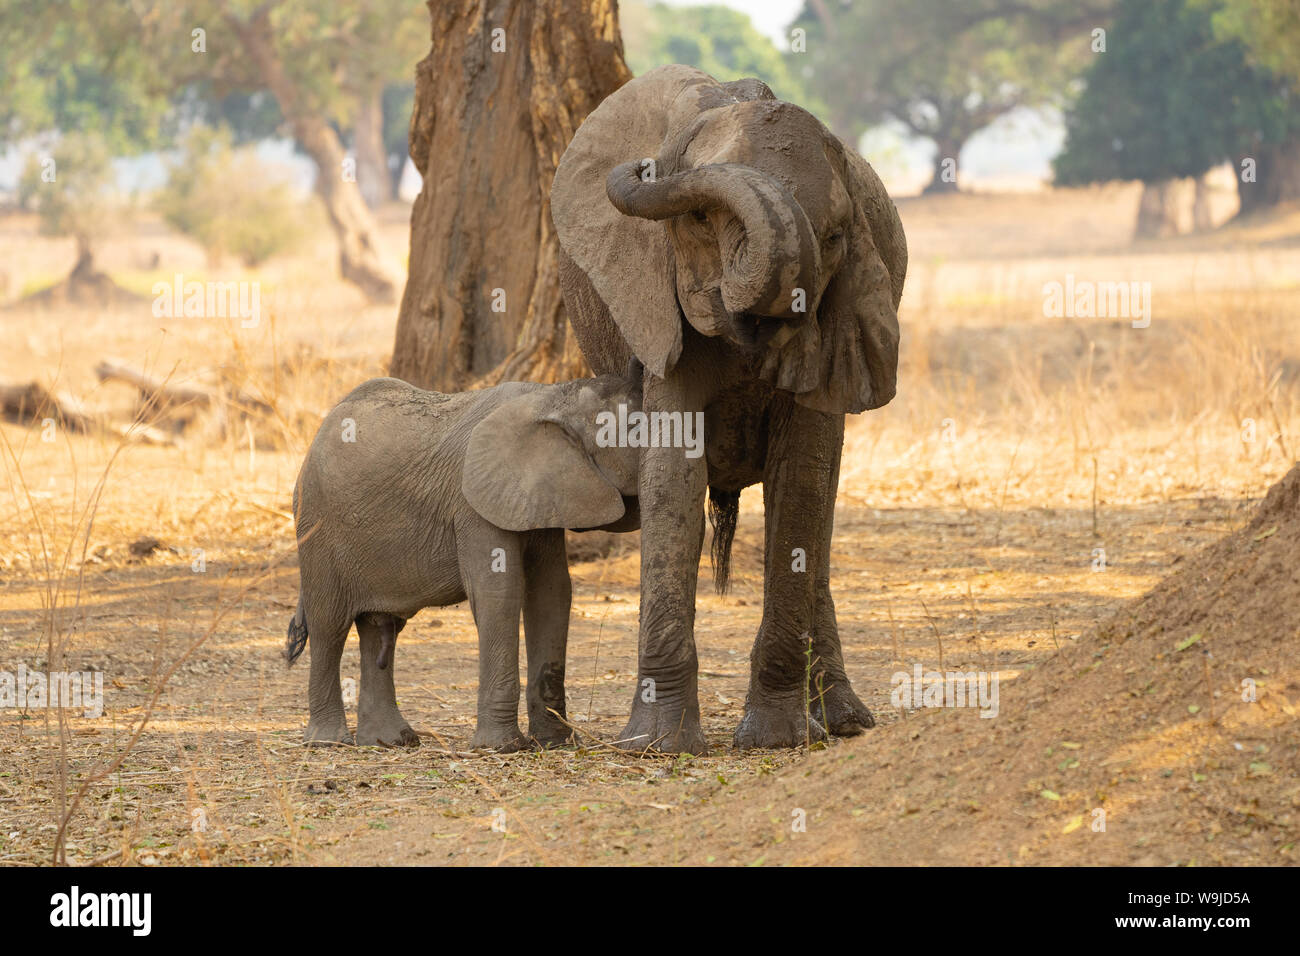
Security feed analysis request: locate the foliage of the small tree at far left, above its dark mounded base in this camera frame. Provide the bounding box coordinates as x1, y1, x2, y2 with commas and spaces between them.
18, 134, 125, 251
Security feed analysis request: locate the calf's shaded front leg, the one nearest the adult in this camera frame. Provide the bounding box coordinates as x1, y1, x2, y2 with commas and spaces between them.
524, 529, 573, 747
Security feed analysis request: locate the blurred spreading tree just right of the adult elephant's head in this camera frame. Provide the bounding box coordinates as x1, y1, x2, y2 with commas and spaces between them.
788, 0, 1112, 193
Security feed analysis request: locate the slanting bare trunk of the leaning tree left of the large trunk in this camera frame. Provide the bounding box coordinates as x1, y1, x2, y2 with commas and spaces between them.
226, 7, 397, 302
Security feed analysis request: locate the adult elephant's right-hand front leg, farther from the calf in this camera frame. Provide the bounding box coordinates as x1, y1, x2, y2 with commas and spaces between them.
736, 393, 852, 749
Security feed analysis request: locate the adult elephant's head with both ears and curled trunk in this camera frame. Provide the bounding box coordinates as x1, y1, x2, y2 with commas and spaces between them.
551, 66, 907, 412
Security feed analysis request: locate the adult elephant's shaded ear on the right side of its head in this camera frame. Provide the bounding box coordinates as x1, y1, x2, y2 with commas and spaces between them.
770, 148, 907, 414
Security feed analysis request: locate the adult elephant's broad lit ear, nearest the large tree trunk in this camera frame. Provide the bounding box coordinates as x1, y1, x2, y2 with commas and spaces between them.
551, 65, 723, 377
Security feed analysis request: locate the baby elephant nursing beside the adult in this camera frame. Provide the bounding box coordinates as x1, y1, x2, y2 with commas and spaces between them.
285, 376, 641, 752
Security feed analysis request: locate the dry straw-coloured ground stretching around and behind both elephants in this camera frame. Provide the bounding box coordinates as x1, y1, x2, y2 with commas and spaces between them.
0, 179, 1300, 865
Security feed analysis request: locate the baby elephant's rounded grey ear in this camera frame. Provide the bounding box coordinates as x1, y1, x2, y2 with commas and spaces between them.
460, 390, 624, 531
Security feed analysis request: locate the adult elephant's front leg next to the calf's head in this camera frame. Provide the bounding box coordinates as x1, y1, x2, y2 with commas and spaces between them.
619, 373, 709, 754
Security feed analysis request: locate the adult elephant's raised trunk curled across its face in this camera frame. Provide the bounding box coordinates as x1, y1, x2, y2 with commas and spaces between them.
605, 161, 820, 319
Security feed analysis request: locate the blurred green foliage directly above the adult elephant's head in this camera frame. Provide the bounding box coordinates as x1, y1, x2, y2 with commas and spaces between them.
619, 3, 818, 112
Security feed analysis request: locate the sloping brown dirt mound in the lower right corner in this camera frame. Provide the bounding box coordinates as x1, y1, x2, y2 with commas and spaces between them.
644, 467, 1300, 865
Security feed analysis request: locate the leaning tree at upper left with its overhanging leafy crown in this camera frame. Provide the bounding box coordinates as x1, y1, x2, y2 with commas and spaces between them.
0, 0, 426, 302
